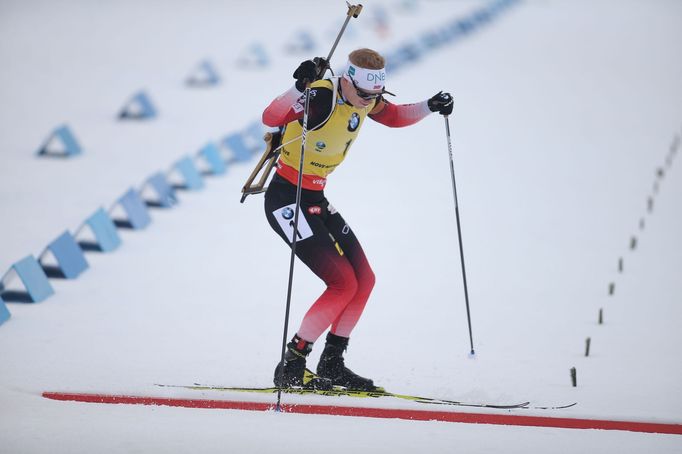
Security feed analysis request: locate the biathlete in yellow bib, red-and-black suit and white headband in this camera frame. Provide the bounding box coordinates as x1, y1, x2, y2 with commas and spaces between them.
263, 49, 453, 390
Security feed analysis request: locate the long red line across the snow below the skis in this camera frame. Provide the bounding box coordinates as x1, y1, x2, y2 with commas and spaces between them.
43, 392, 682, 435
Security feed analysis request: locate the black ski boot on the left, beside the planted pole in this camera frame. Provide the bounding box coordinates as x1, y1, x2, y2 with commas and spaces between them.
274, 335, 332, 390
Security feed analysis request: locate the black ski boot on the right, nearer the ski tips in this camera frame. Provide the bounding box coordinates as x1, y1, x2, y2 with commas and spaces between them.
317, 333, 377, 391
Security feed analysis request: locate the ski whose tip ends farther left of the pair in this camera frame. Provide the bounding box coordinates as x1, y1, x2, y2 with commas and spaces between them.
155, 383, 530, 410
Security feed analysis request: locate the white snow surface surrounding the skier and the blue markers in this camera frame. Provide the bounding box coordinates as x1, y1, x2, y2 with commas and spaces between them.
0, 0, 682, 453
